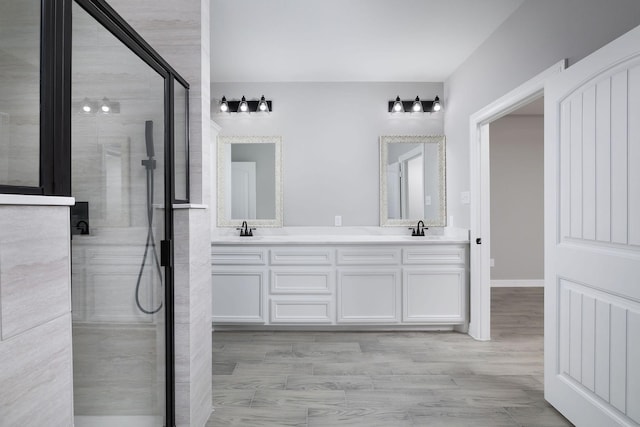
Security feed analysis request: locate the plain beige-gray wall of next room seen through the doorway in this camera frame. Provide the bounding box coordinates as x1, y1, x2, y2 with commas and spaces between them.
489, 116, 544, 280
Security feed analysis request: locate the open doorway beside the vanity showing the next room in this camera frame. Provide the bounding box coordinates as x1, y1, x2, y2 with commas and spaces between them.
489, 97, 544, 342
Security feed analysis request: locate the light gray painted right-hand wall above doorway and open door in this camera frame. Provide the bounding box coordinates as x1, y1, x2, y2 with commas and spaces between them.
441, 0, 640, 227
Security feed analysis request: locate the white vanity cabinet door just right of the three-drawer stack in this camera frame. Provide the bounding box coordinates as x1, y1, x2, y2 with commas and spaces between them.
338, 268, 400, 323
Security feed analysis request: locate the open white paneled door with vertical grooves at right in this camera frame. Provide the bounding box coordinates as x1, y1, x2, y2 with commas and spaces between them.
545, 27, 640, 426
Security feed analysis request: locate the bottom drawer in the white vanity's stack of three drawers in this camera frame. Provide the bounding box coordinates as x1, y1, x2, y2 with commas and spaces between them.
269, 297, 334, 324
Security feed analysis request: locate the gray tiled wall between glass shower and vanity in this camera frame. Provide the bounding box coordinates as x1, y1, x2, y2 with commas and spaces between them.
109, 0, 212, 427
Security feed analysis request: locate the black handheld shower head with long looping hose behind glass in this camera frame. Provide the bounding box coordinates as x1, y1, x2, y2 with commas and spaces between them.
136, 120, 162, 314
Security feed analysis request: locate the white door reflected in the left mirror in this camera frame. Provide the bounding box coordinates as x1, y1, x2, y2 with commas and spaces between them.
231, 162, 256, 219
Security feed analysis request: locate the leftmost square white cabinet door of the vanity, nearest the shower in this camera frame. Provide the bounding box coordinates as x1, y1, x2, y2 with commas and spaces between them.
211, 268, 266, 323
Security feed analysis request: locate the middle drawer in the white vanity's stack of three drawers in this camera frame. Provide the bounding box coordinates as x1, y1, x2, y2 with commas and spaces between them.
269, 267, 335, 294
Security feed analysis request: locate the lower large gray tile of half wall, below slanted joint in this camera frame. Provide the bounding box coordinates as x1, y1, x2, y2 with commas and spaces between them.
0, 313, 73, 427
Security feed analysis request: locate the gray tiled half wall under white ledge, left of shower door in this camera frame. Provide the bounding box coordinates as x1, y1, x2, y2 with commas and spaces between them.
0, 205, 73, 427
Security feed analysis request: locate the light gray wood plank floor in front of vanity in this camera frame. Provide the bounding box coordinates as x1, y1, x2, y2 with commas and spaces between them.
207, 288, 571, 427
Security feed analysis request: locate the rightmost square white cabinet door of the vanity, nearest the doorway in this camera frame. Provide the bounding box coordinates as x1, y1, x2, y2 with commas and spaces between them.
402, 267, 466, 324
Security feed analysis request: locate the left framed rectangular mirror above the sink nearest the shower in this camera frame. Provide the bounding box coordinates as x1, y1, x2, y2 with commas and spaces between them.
217, 136, 282, 227
